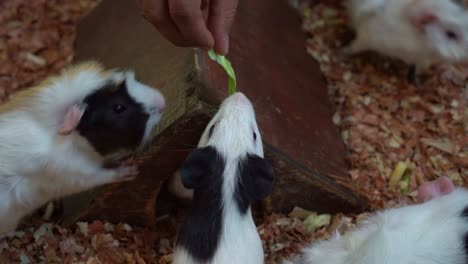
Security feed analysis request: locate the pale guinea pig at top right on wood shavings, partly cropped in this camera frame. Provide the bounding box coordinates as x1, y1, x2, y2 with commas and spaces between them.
344, 0, 468, 78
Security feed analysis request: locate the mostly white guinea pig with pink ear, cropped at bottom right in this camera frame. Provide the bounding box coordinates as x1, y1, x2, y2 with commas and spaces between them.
286, 178, 468, 264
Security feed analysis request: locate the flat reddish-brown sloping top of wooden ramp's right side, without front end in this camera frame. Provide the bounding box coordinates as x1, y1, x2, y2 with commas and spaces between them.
200, 0, 346, 177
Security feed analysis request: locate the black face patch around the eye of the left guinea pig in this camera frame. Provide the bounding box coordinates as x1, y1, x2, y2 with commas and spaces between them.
77, 82, 149, 155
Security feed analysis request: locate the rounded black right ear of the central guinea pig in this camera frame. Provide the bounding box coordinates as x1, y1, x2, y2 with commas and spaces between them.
240, 154, 274, 200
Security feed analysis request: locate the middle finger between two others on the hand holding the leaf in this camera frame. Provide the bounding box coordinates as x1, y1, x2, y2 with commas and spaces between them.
169, 0, 214, 49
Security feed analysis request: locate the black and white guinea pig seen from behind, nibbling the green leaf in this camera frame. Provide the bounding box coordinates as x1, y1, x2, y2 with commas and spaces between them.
173, 93, 273, 264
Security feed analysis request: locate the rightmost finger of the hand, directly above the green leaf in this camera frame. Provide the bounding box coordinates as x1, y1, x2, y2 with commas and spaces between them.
208, 0, 237, 55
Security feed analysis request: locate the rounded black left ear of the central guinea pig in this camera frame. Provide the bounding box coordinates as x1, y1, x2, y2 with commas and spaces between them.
180, 147, 217, 189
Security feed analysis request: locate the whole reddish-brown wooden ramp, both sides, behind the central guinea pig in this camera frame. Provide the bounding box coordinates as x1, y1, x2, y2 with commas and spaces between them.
69, 0, 365, 224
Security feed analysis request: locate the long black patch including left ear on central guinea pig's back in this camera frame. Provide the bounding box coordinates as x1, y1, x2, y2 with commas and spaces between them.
177, 147, 225, 263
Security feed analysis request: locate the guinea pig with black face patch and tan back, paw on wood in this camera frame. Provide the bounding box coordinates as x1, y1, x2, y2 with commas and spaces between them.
0, 62, 165, 234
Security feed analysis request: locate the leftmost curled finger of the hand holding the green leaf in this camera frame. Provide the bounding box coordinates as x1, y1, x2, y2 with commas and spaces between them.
137, 0, 189, 47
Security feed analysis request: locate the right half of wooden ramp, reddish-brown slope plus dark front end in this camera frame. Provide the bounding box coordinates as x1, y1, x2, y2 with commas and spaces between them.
197, 0, 365, 212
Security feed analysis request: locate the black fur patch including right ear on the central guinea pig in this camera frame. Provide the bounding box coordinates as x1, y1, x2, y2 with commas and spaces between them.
234, 154, 273, 214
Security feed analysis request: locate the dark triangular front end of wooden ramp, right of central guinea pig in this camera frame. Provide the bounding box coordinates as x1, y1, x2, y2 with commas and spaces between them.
263, 145, 366, 213
